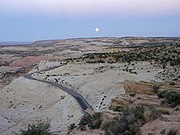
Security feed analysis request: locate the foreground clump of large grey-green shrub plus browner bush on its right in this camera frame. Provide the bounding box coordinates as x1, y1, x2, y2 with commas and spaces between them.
102, 106, 160, 135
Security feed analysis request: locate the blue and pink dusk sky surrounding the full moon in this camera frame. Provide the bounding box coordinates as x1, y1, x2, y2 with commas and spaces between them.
0, 0, 180, 41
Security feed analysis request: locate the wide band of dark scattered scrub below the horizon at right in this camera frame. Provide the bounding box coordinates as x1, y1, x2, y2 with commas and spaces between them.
83, 45, 180, 68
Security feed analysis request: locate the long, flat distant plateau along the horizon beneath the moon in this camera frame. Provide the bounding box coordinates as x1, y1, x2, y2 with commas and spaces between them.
32, 37, 180, 47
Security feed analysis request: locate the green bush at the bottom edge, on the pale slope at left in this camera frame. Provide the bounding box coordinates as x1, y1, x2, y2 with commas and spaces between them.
17, 121, 53, 135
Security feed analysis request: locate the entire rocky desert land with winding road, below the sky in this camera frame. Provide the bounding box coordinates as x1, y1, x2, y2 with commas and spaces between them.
0, 37, 180, 135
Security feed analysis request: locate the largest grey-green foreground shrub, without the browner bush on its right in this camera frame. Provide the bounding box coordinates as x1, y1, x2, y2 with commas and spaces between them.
106, 107, 144, 135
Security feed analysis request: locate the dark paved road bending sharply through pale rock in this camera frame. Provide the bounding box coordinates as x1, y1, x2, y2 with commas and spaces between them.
24, 65, 93, 111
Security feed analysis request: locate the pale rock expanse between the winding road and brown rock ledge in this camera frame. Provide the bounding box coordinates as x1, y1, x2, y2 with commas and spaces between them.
34, 62, 162, 111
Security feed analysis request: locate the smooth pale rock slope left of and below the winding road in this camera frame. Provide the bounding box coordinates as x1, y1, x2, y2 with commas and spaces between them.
0, 77, 83, 135
